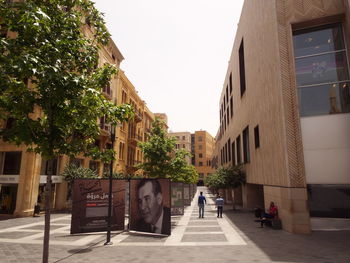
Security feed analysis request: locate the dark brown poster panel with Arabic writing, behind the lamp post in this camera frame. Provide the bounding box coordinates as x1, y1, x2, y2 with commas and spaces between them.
71, 179, 126, 234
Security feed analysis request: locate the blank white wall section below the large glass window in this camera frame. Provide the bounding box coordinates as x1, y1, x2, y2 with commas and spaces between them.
300, 113, 350, 184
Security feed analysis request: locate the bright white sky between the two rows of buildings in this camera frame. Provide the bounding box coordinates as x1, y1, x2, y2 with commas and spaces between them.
95, 0, 243, 136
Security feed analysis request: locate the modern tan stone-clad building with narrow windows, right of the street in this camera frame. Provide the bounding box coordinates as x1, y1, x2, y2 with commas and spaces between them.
216, 0, 350, 233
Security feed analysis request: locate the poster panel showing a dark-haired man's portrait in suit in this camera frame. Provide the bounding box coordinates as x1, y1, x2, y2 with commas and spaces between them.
130, 178, 171, 235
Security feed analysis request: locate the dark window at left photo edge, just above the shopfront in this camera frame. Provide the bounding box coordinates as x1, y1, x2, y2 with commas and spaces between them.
0, 152, 22, 175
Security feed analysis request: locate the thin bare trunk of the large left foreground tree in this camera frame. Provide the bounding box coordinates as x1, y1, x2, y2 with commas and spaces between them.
43, 159, 53, 263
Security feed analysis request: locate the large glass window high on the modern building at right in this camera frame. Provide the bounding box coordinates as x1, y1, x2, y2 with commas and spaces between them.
293, 24, 350, 116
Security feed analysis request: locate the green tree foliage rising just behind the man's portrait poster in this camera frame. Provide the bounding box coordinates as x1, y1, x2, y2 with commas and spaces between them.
138, 119, 198, 183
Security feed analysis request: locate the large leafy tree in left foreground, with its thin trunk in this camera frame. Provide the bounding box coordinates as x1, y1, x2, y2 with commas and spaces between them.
0, 0, 132, 262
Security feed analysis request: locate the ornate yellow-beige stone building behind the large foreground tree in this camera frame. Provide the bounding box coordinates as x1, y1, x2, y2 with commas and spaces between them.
0, 28, 154, 216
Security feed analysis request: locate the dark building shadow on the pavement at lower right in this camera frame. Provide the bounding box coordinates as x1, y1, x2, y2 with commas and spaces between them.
224, 207, 350, 263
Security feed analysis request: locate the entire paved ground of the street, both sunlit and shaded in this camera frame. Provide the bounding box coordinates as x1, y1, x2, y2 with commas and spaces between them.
0, 188, 350, 263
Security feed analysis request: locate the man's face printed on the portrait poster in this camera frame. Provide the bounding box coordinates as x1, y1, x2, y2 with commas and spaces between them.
138, 182, 163, 224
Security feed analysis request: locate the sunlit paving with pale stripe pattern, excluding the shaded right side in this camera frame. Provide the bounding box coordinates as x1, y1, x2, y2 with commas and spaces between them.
0, 188, 246, 247
